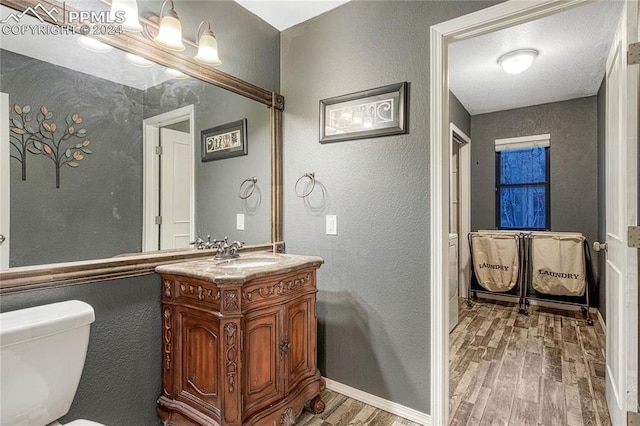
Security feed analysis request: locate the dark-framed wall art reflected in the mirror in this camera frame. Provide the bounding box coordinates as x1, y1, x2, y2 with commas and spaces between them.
200, 118, 247, 162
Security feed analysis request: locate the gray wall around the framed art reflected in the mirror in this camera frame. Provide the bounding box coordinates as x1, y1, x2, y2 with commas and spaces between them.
144, 78, 271, 244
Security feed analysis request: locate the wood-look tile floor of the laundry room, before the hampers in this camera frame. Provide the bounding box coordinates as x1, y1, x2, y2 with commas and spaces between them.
449, 299, 611, 426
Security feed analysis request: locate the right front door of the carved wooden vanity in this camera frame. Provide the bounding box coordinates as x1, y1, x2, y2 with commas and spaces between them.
286, 294, 316, 393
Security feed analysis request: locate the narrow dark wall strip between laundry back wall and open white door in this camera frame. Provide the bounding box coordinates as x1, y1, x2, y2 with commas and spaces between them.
591, 79, 607, 321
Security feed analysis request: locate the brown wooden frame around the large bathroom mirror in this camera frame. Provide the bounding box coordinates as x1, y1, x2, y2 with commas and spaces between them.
0, 0, 284, 295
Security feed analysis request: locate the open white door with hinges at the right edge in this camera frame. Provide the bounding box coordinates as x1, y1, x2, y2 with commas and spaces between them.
606, 0, 638, 425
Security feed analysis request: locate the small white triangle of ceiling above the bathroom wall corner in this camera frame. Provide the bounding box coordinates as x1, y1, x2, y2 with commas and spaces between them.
235, 0, 349, 31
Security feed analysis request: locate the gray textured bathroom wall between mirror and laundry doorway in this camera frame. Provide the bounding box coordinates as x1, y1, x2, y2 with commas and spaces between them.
281, 1, 502, 413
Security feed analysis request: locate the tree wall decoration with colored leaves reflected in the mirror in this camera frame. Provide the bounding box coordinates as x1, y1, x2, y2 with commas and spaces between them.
11, 104, 93, 188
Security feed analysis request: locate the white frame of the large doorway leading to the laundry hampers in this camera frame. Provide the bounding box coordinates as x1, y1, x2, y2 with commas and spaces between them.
429, 0, 624, 425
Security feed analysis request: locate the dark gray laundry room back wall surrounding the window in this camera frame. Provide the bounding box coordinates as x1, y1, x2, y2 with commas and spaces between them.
471, 96, 600, 296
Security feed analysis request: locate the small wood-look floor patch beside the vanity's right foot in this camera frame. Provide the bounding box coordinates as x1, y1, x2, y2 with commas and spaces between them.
296, 390, 419, 426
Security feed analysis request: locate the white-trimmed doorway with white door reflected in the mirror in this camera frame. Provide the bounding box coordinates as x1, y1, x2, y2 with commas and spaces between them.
142, 105, 195, 251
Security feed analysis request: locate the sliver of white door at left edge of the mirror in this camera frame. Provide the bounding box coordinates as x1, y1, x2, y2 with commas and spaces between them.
0, 93, 11, 270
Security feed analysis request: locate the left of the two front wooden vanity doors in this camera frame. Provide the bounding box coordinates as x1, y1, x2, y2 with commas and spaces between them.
243, 306, 283, 415
